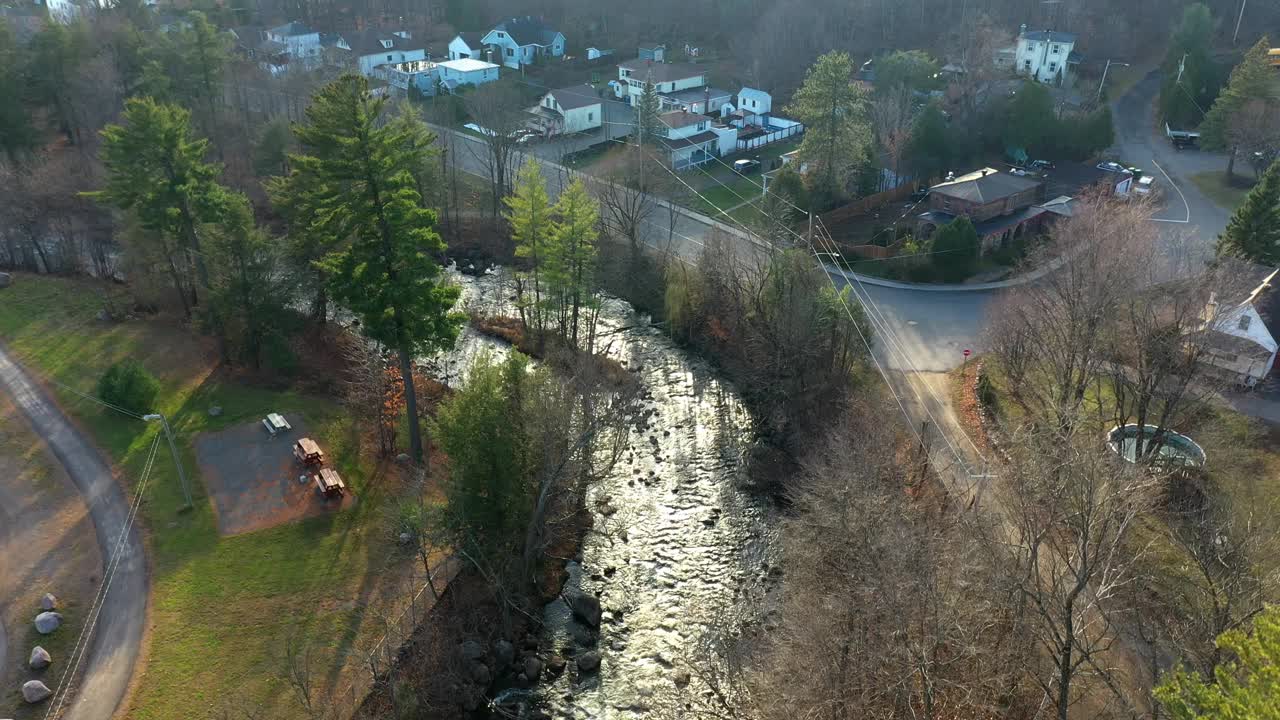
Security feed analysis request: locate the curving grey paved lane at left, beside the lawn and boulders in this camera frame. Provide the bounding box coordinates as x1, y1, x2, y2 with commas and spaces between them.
0, 348, 148, 720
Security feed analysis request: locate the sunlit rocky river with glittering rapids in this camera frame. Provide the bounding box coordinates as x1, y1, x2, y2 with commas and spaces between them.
436, 270, 777, 719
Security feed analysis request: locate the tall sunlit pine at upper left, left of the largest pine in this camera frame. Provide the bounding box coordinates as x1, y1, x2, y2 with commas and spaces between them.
88, 97, 229, 318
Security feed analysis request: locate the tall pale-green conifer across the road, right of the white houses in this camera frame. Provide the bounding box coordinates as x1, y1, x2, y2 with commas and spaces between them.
787, 51, 872, 199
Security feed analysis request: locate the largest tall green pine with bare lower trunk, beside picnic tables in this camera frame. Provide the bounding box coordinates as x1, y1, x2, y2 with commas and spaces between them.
276, 74, 462, 461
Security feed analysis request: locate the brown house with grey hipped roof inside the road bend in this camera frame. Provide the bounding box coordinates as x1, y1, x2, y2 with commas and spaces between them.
916, 168, 1050, 252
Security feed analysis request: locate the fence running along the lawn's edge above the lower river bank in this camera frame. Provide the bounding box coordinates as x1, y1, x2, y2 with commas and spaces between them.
317, 556, 462, 720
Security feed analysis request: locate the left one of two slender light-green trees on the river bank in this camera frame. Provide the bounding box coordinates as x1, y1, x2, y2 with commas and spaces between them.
503, 158, 552, 333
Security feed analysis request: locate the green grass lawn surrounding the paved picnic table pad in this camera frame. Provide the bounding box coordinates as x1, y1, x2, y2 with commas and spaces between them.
0, 274, 435, 720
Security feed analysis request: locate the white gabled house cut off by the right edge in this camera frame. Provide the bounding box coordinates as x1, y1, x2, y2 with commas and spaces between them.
1201, 260, 1280, 388
